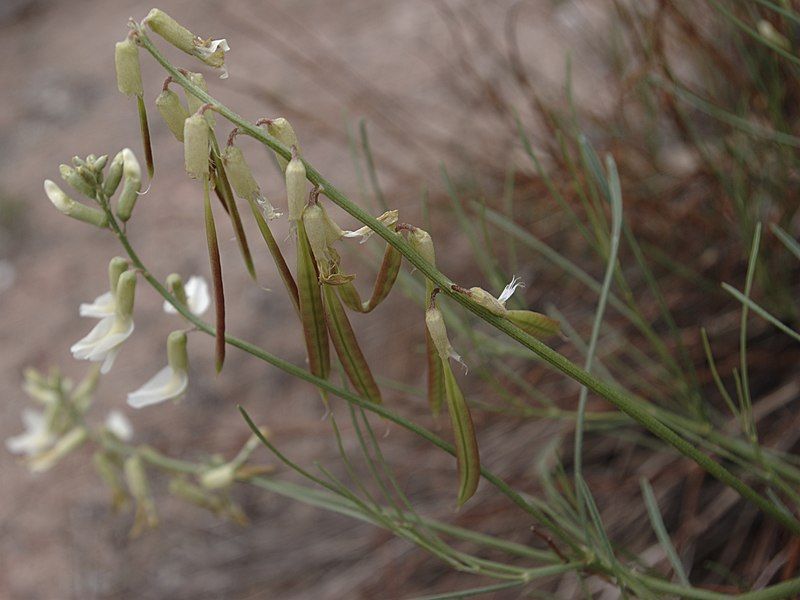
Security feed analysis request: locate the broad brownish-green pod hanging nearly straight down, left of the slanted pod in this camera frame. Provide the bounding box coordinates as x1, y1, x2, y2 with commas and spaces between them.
297, 220, 331, 379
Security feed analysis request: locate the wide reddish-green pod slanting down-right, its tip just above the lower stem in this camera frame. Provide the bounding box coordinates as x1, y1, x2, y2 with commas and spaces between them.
322, 284, 382, 404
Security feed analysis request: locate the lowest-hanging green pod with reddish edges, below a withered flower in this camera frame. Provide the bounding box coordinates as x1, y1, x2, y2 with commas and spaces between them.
442, 360, 481, 507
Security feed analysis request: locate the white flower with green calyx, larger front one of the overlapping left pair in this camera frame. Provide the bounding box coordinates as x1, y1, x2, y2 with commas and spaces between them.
70, 271, 136, 373
